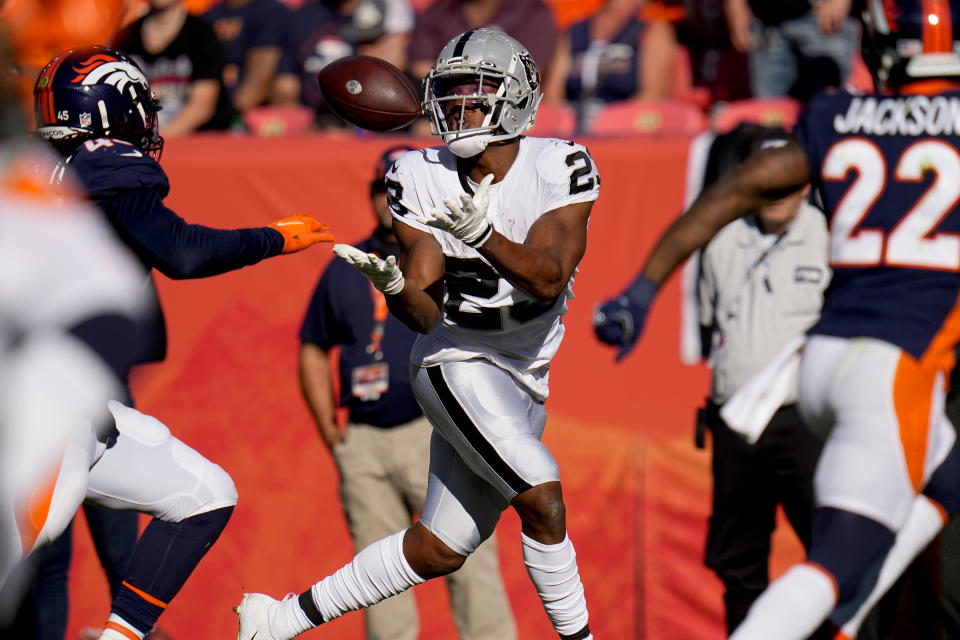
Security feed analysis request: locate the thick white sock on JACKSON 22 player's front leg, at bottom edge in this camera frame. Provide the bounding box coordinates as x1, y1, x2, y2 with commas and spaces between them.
730, 564, 837, 640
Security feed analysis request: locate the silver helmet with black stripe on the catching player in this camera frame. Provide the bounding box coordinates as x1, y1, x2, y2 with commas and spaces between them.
423, 29, 543, 158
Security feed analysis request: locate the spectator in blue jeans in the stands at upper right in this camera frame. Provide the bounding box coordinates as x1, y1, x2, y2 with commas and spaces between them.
725, 0, 862, 99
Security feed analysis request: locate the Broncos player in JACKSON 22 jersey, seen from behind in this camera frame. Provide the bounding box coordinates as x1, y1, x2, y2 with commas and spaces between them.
594, 0, 960, 640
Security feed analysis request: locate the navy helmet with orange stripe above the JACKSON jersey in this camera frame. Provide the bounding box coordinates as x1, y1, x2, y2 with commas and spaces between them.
863, 0, 960, 90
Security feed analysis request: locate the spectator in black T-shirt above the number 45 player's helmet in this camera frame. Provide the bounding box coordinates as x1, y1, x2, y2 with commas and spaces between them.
115, 0, 237, 139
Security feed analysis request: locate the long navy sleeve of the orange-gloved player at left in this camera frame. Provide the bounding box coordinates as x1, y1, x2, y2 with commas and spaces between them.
70, 140, 283, 279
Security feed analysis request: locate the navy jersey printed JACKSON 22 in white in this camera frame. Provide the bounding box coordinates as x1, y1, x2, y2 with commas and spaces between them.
794, 91, 960, 359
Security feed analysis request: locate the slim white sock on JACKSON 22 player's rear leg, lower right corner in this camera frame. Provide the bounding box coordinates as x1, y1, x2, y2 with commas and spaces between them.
830, 495, 945, 638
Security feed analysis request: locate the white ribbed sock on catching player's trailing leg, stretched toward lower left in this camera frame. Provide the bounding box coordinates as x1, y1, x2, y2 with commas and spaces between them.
310, 531, 424, 622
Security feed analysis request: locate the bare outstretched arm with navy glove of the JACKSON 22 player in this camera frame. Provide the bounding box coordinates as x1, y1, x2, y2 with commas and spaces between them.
593, 140, 811, 360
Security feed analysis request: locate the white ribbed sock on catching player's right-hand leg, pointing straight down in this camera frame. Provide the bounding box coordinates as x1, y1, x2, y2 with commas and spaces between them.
520, 532, 593, 640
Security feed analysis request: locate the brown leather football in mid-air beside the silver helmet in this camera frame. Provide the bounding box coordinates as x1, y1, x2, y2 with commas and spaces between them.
317, 56, 420, 131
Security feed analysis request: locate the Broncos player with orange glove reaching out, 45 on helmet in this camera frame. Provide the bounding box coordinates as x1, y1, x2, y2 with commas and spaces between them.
34, 47, 333, 640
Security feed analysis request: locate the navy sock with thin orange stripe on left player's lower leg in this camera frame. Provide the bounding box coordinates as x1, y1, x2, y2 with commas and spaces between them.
111, 507, 233, 633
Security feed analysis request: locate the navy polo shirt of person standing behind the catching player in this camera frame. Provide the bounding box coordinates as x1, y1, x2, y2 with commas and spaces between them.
300, 236, 421, 427
